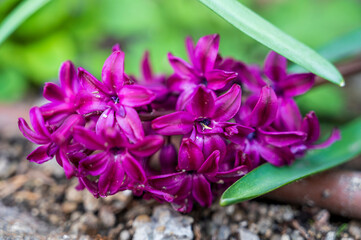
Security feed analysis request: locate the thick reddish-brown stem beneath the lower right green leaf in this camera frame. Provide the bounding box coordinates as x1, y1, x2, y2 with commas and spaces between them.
266, 170, 361, 219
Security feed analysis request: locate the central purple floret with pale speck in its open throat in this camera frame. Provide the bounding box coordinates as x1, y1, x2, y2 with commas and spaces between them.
152, 84, 253, 135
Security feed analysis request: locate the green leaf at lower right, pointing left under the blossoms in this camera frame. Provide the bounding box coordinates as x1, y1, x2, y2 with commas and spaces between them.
220, 118, 361, 206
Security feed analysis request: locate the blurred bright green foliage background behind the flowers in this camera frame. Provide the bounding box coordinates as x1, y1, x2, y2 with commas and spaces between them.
0, 0, 361, 124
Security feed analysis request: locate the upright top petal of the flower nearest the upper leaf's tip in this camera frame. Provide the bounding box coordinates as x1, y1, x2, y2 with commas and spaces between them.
264, 51, 287, 82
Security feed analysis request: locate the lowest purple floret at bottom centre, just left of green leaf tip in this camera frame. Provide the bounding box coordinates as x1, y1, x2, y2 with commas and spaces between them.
149, 138, 220, 212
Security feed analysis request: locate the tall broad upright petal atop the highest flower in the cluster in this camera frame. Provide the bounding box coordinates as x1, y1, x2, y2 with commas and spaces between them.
194, 34, 219, 73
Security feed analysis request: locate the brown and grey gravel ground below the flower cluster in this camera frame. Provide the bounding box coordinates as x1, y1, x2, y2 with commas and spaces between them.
0, 138, 361, 240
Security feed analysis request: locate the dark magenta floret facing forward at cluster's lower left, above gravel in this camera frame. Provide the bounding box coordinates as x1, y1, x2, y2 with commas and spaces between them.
74, 124, 163, 197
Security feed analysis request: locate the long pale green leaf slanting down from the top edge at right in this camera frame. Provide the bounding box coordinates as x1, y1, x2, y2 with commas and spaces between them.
199, 0, 344, 86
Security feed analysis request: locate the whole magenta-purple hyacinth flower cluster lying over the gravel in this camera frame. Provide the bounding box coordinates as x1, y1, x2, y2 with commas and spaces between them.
19, 34, 340, 212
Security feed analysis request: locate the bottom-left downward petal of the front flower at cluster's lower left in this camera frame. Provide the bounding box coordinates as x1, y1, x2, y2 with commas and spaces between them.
98, 160, 124, 197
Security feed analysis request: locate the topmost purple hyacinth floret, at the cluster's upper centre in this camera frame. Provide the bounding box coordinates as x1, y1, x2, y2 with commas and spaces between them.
168, 34, 237, 110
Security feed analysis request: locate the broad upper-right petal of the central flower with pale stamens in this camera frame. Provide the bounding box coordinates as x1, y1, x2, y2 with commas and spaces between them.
212, 84, 242, 122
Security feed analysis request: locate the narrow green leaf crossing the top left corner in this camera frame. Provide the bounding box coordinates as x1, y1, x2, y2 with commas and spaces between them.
0, 0, 49, 45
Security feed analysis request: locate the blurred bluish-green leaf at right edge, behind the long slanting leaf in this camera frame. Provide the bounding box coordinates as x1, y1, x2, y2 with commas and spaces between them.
288, 28, 361, 72
